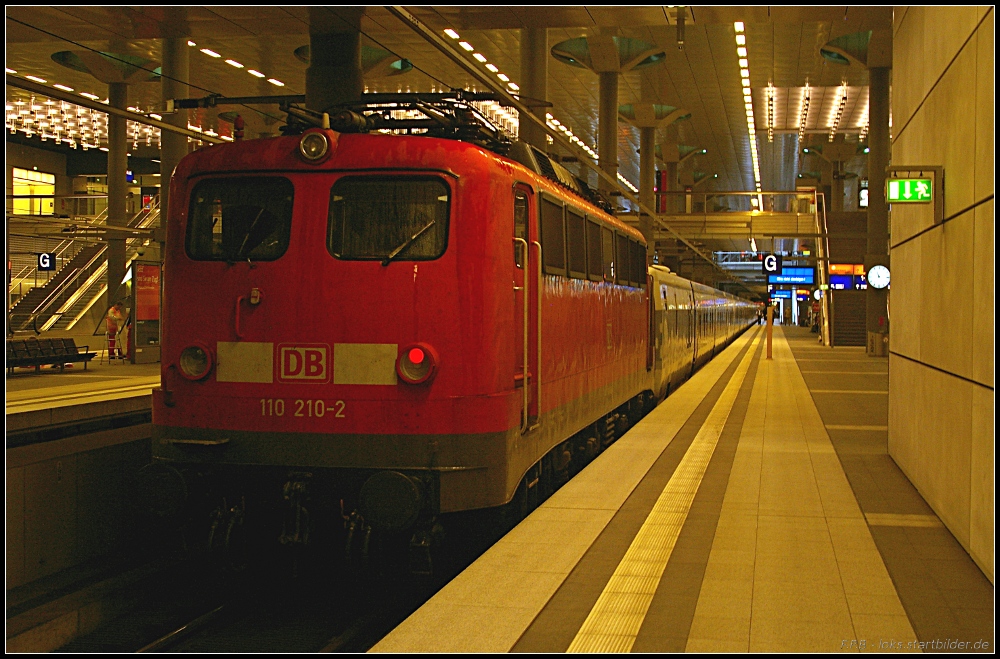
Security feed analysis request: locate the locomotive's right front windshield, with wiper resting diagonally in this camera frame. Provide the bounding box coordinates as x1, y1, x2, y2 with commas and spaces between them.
327, 176, 451, 265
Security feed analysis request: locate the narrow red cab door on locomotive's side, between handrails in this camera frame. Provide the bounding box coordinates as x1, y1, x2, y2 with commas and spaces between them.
512, 184, 541, 433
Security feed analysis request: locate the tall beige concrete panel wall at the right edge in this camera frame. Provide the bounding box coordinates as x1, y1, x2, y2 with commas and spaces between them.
892, 7, 995, 581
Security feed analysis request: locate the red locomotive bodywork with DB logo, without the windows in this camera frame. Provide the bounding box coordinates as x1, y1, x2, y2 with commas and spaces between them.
153, 131, 650, 511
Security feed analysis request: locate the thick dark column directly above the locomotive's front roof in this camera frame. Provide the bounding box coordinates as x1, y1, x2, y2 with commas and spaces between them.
306, 7, 365, 112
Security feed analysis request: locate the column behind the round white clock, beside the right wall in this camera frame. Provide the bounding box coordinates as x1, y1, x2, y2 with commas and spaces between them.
865, 67, 891, 332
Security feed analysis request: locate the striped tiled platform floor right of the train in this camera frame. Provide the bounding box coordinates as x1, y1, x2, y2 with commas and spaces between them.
371, 327, 994, 652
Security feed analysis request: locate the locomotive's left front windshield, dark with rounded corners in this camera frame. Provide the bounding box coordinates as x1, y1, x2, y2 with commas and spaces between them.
186, 176, 295, 263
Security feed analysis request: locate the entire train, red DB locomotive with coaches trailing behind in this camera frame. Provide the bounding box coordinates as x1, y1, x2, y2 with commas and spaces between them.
147, 95, 753, 564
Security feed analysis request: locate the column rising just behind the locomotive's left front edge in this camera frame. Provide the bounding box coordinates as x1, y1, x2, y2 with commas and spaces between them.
160, 38, 190, 258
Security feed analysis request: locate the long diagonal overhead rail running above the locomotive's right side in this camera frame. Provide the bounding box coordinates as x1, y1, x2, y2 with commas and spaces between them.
386, 6, 753, 293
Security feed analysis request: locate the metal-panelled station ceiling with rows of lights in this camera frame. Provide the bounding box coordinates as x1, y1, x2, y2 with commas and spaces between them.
6, 5, 891, 288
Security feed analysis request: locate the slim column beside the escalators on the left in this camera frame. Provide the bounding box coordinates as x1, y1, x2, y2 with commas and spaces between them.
105, 82, 129, 305
